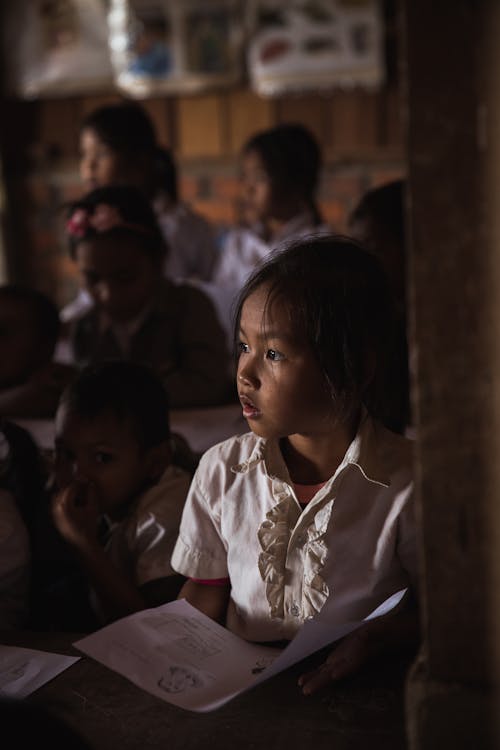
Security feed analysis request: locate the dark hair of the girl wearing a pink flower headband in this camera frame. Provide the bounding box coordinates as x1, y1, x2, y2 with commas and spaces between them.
66, 185, 167, 263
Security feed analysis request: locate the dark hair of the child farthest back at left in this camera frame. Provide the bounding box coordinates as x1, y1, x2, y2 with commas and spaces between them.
80, 102, 178, 203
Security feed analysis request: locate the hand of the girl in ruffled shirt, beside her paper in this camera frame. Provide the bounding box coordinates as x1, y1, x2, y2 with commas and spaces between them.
299, 624, 378, 695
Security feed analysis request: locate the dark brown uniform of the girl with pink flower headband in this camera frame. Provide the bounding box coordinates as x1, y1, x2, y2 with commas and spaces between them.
70, 279, 230, 408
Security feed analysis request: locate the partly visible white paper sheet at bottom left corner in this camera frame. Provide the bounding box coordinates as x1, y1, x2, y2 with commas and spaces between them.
0, 645, 81, 698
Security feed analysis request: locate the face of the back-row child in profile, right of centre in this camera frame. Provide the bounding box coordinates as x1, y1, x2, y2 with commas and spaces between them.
240, 151, 272, 226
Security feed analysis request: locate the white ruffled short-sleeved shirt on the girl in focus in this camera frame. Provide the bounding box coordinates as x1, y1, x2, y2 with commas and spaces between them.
172, 415, 417, 641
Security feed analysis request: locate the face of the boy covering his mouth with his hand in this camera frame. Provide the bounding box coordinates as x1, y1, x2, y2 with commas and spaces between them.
56, 405, 158, 516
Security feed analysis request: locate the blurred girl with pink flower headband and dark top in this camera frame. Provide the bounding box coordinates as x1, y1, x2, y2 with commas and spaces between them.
63, 186, 229, 408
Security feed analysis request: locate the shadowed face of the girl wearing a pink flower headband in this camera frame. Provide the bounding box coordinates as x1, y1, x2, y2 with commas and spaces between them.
75, 234, 160, 323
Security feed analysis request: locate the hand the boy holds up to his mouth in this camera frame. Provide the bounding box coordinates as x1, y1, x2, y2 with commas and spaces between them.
52, 482, 100, 548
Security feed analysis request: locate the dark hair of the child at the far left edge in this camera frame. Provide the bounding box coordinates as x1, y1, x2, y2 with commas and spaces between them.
0, 284, 61, 356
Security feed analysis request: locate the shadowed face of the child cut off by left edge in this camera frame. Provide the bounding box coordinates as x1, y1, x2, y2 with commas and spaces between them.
0, 298, 44, 388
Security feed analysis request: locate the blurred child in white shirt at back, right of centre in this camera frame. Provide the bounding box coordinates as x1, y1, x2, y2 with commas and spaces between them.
203, 124, 330, 344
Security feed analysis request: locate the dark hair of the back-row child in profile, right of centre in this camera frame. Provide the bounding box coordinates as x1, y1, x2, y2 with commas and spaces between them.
243, 123, 322, 224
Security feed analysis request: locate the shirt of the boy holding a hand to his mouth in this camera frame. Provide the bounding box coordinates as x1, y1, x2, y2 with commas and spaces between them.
105, 465, 191, 586
